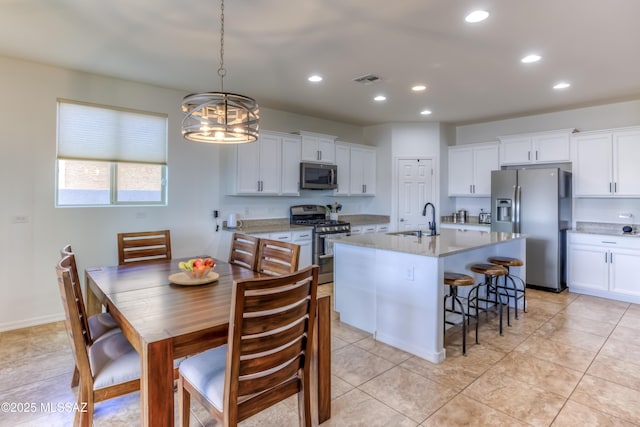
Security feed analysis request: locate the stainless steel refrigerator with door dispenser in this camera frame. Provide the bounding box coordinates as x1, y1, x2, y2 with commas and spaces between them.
491, 168, 571, 292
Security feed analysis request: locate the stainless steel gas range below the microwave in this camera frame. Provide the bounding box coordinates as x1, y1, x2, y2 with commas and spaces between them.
290, 205, 351, 284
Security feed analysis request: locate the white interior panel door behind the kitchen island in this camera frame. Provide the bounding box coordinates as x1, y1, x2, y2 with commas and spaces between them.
397, 159, 437, 230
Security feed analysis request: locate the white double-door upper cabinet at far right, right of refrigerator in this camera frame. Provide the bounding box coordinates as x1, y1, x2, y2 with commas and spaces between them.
571, 127, 640, 197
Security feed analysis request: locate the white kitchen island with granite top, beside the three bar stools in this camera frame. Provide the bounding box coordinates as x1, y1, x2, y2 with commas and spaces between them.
334, 229, 526, 363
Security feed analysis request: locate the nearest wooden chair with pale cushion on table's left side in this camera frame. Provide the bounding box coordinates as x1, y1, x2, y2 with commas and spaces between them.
56, 257, 140, 427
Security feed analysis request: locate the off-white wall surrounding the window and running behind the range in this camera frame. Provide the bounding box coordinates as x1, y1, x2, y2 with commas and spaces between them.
0, 57, 370, 330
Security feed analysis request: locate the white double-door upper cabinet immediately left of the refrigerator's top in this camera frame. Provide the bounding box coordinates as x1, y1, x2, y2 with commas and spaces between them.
449, 143, 500, 197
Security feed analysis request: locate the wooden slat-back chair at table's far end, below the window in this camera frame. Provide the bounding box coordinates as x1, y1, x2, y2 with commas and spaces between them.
118, 230, 171, 265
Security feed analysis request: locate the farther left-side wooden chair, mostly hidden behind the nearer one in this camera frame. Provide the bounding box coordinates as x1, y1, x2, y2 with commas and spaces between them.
60, 245, 120, 387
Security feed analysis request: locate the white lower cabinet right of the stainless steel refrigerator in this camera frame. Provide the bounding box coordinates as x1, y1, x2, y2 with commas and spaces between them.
568, 233, 640, 303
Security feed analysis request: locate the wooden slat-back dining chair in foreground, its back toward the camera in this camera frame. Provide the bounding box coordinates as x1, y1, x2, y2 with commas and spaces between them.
178, 266, 318, 427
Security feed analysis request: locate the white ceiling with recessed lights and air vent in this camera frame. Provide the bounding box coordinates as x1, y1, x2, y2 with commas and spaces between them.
0, 0, 640, 125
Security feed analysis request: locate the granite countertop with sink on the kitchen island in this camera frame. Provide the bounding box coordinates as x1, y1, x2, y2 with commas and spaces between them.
334, 229, 526, 257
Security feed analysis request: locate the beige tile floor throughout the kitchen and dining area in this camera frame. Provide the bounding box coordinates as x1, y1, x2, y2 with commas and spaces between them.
0, 285, 640, 427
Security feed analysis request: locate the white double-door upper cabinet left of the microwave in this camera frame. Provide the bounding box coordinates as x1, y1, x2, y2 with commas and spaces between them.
221, 131, 301, 196
